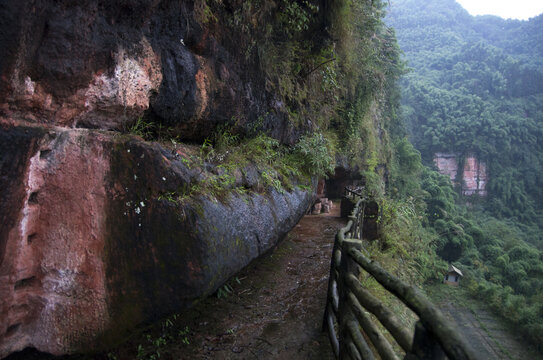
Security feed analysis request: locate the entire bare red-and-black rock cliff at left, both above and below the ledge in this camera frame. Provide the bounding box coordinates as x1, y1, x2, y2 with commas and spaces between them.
0, 0, 312, 358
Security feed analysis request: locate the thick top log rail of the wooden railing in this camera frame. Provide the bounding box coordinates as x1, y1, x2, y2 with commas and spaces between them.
348, 249, 477, 360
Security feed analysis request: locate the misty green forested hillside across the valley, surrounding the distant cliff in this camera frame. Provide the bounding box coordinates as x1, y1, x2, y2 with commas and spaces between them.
386, 0, 543, 352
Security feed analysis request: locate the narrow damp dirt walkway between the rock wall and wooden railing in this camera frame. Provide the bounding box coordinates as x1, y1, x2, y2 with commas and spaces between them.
173, 206, 345, 359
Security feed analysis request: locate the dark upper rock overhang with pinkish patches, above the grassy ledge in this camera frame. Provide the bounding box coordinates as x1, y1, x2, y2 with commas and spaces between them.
0, 0, 298, 143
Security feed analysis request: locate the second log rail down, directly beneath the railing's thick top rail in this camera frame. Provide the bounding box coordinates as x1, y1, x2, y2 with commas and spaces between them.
345, 274, 415, 352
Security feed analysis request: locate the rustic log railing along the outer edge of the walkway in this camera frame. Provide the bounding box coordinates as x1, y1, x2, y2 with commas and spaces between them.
323, 189, 477, 360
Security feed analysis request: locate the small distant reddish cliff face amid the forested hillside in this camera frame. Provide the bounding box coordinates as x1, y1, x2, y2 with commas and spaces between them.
434, 153, 487, 196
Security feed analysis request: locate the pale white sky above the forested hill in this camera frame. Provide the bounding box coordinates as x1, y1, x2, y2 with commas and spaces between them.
456, 0, 543, 20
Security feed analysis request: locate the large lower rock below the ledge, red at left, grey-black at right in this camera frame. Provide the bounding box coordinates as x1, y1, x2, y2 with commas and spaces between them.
0, 125, 312, 357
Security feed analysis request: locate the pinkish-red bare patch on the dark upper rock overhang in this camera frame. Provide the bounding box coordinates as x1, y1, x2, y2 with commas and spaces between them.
3, 39, 162, 129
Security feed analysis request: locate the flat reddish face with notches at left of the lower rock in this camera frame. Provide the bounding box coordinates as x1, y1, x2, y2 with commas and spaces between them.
0, 131, 109, 357
